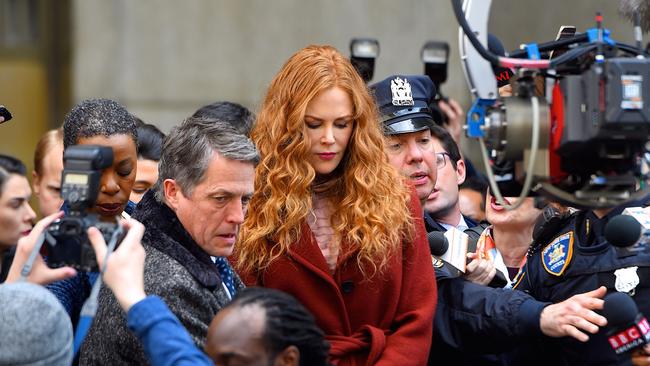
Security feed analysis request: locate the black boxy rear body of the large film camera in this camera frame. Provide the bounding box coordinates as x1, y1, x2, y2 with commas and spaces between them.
554, 57, 650, 176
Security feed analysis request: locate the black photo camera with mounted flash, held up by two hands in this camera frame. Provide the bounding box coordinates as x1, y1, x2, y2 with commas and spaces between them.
45, 145, 122, 272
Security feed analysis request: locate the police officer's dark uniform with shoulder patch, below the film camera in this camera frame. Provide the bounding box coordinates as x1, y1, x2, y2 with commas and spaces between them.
514, 198, 650, 365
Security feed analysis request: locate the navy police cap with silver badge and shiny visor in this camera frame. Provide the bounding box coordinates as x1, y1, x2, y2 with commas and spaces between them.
370, 75, 436, 135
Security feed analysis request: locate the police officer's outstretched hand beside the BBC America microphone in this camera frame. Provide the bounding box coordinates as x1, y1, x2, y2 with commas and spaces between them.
539, 286, 607, 342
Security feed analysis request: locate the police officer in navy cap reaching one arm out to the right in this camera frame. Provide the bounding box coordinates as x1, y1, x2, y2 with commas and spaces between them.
371, 75, 604, 365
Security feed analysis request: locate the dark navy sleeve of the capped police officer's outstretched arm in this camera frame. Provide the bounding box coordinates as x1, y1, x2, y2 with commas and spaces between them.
434, 268, 548, 353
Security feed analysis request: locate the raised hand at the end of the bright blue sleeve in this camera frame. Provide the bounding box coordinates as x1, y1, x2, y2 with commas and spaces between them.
88, 219, 147, 312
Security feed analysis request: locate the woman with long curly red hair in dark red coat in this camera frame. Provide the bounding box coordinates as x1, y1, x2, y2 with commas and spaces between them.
236, 46, 436, 365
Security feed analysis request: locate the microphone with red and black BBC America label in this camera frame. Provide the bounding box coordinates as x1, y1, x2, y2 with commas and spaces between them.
603, 292, 650, 355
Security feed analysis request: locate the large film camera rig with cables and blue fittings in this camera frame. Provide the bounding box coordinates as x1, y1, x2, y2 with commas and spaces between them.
452, 0, 650, 208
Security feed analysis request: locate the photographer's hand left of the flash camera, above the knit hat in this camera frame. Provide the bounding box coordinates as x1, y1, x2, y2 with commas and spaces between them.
6, 211, 77, 285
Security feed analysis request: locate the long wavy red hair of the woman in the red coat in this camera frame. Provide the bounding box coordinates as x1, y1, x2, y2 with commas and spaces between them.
236, 45, 413, 278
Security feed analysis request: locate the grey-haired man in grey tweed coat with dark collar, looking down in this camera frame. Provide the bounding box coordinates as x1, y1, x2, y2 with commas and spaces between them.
80, 117, 259, 365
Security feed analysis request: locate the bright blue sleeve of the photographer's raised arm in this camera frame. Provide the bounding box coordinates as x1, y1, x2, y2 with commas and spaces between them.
127, 296, 212, 366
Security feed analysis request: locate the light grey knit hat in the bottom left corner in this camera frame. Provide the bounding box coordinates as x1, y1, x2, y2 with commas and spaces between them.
0, 282, 72, 366
